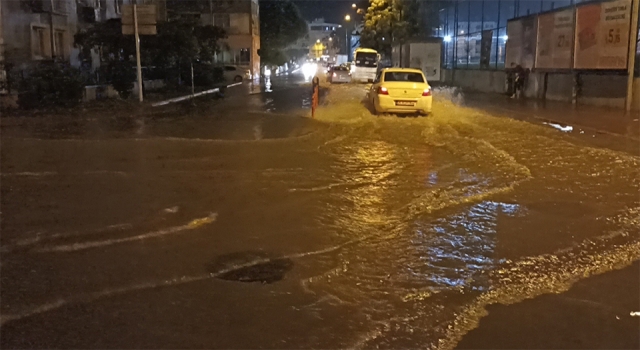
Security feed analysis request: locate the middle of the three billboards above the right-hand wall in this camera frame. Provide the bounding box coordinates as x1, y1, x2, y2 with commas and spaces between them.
536, 9, 574, 69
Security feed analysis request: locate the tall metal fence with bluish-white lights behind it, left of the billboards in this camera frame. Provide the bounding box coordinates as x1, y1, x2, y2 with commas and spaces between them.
435, 0, 596, 69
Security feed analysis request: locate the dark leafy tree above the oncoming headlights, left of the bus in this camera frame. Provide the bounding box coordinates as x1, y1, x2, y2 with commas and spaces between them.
258, 0, 308, 65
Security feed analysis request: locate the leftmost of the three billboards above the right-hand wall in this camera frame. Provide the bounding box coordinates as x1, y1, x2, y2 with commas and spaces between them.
505, 16, 537, 69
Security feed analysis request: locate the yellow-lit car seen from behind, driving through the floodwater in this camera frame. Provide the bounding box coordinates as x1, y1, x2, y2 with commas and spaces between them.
368, 68, 432, 115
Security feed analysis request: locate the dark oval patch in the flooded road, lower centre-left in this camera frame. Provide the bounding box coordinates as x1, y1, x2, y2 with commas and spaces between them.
208, 252, 293, 284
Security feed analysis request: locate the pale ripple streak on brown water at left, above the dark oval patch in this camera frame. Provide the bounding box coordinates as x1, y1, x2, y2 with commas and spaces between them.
37, 213, 218, 252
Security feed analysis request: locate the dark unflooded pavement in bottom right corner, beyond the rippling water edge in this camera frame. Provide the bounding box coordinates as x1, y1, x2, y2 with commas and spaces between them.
457, 261, 640, 349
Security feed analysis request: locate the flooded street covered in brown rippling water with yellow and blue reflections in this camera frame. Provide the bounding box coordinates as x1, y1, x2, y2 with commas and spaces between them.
0, 73, 640, 349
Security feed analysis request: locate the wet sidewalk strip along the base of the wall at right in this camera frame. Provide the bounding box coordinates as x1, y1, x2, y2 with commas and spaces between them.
463, 92, 640, 140
